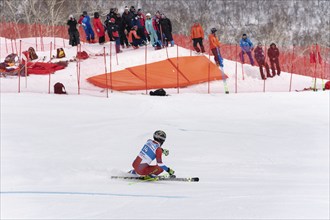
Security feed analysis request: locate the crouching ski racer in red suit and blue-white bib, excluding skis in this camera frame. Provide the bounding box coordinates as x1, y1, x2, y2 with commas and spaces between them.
129, 130, 174, 177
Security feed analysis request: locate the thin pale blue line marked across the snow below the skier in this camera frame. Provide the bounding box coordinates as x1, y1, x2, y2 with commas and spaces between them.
0, 191, 187, 199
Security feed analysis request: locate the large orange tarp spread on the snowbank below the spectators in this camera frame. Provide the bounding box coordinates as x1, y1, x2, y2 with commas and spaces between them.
87, 56, 227, 91
